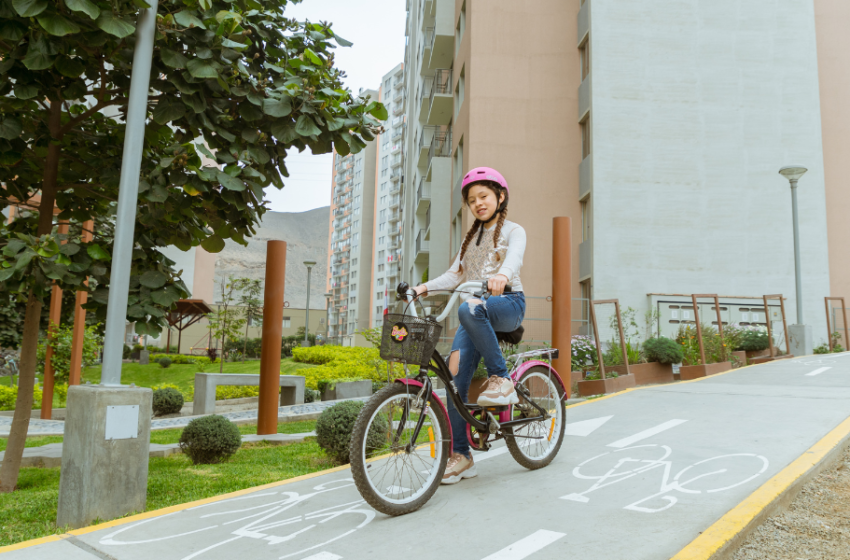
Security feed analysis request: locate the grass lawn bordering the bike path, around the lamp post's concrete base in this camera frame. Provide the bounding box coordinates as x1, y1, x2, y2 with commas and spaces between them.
0, 420, 334, 546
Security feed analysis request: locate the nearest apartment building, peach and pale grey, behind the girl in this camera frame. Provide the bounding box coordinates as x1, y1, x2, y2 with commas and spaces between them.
402, 0, 850, 343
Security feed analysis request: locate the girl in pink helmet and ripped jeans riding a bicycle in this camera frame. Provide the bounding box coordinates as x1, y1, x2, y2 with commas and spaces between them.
415, 167, 526, 484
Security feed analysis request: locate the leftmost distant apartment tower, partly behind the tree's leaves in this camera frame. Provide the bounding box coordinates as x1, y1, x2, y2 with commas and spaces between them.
327, 90, 378, 345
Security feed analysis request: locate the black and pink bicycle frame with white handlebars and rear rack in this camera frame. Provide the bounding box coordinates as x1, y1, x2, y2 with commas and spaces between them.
396, 282, 566, 448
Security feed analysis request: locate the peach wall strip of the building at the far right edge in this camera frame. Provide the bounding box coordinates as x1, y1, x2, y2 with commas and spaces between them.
814, 0, 850, 306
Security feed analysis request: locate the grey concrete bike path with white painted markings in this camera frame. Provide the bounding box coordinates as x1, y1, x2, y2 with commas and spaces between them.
0, 353, 850, 560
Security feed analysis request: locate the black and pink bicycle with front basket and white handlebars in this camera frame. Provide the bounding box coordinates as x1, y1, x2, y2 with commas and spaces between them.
349, 281, 567, 516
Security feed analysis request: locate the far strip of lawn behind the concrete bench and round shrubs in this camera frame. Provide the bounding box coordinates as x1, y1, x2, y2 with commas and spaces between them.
78, 358, 315, 393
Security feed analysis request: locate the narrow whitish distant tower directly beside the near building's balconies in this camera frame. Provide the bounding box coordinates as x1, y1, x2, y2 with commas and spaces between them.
370, 64, 405, 326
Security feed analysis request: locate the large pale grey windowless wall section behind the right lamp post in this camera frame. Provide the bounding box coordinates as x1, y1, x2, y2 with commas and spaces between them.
588, 0, 829, 342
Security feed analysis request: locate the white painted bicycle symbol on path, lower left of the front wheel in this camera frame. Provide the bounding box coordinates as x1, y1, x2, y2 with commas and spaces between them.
100, 478, 375, 560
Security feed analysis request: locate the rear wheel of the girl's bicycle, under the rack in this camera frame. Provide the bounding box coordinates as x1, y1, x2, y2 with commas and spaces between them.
505, 366, 567, 470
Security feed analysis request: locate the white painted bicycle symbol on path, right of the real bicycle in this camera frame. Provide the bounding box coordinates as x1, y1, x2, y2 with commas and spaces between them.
563, 444, 769, 513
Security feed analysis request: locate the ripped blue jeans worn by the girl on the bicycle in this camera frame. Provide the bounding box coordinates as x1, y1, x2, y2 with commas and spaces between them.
446, 292, 525, 457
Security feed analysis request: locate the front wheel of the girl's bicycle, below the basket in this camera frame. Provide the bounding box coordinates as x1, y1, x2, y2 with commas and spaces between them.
350, 383, 451, 515
